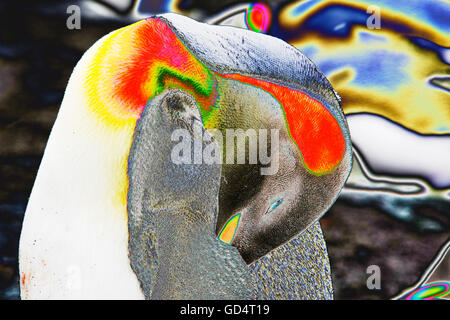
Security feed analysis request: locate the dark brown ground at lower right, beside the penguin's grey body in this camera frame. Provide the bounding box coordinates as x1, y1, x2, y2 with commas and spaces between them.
321, 200, 449, 299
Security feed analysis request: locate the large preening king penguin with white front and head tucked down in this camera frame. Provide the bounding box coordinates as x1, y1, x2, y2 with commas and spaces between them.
19, 14, 351, 299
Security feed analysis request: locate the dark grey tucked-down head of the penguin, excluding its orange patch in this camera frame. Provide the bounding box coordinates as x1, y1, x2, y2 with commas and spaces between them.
216, 79, 351, 263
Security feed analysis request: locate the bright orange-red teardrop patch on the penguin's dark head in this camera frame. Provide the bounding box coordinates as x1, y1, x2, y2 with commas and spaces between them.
216, 74, 345, 175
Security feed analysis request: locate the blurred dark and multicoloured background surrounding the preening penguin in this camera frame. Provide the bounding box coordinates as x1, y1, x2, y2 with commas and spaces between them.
0, 0, 450, 299
